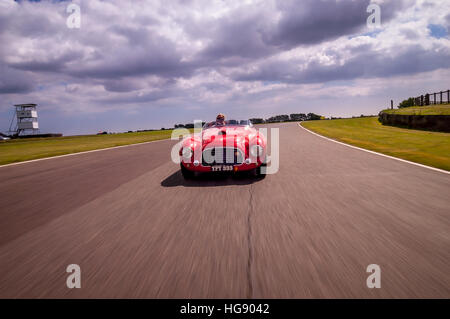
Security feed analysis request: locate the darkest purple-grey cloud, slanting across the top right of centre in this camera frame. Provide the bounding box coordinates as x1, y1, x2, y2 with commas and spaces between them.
193, 0, 405, 66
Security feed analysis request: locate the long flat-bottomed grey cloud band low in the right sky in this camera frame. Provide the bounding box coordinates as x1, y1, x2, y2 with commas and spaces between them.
233, 45, 450, 84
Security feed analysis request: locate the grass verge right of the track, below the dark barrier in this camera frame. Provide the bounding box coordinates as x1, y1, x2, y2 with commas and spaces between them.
302, 117, 450, 171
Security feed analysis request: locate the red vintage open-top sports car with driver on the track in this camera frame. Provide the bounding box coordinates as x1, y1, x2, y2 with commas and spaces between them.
180, 120, 266, 179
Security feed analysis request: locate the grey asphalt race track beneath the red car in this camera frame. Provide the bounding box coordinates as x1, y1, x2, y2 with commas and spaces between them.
0, 123, 450, 298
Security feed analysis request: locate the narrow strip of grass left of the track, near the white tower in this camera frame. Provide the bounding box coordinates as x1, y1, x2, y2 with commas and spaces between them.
0, 130, 183, 165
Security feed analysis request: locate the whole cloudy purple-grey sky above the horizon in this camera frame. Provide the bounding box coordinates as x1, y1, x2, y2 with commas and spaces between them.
0, 0, 450, 135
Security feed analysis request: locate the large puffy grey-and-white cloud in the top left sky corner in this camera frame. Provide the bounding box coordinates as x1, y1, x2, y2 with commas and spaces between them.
0, 2, 195, 92
